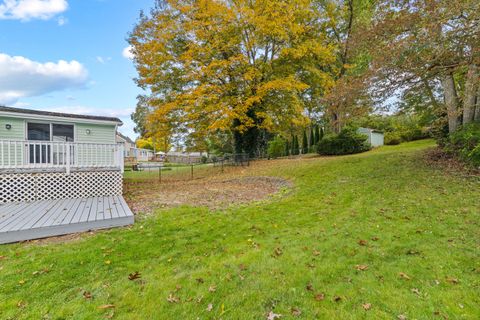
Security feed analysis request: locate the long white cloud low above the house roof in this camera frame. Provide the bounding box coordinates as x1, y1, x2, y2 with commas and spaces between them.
0, 53, 88, 104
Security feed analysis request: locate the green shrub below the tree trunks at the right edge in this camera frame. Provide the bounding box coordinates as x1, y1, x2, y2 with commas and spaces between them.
444, 123, 480, 166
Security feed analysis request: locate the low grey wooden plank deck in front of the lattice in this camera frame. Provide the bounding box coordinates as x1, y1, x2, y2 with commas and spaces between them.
0, 196, 134, 244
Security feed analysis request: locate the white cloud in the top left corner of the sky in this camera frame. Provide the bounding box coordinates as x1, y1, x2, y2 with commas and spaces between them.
0, 0, 68, 23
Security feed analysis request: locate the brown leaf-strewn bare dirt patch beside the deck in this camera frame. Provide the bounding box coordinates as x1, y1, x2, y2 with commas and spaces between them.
125, 177, 291, 213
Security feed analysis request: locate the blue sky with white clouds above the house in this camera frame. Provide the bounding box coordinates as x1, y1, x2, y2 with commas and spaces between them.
0, 0, 154, 138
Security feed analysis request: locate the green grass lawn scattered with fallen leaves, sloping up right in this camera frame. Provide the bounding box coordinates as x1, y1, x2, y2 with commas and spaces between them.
0, 141, 480, 319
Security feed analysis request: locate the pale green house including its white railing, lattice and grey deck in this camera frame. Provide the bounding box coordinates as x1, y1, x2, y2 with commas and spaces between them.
0, 106, 134, 243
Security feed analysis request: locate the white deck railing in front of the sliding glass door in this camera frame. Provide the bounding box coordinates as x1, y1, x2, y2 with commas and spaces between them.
0, 140, 124, 173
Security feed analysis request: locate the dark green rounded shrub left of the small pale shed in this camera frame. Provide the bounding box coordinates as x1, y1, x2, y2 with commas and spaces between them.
317, 128, 370, 155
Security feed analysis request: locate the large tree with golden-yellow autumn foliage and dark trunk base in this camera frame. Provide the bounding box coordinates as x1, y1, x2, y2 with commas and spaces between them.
129, 0, 335, 155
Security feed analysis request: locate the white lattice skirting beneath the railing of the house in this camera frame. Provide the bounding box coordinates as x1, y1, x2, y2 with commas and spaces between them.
0, 171, 123, 203
